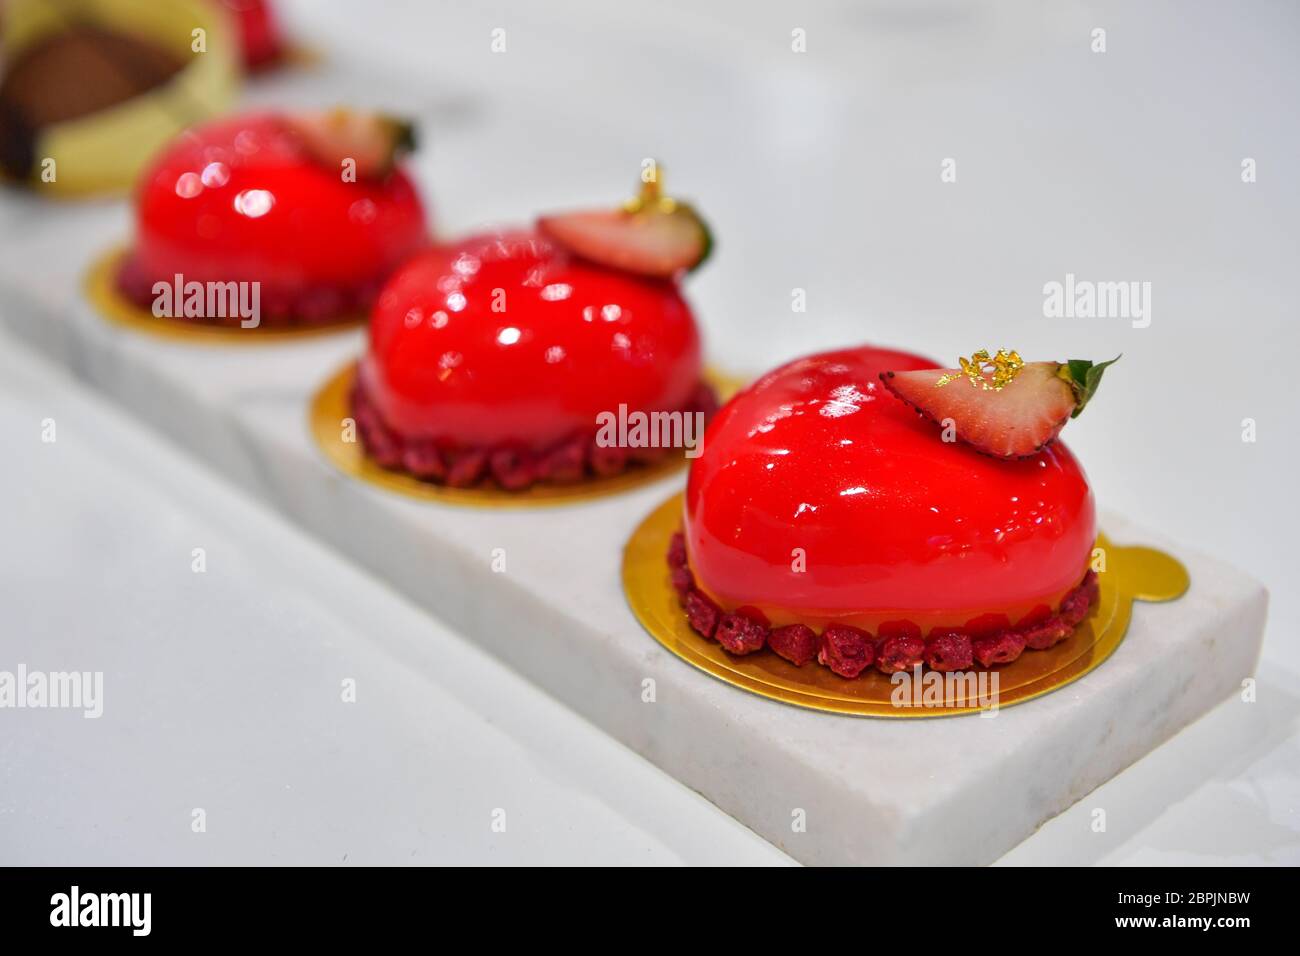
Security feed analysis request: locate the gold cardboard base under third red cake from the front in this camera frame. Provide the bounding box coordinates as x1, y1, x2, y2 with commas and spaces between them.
86, 246, 367, 345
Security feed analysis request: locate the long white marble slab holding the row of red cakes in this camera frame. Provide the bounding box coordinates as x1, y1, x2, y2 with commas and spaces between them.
0, 222, 1266, 864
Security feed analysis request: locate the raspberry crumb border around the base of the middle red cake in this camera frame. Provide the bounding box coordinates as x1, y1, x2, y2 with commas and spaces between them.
348, 378, 718, 492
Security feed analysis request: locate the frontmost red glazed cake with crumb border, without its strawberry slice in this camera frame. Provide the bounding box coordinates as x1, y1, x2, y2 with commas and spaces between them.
668, 347, 1097, 678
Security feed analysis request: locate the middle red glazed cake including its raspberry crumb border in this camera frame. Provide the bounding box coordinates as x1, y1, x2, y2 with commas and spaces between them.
352, 174, 715, 490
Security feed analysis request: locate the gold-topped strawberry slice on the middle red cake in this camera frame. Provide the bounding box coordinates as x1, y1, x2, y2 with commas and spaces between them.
537, 170, 712, 278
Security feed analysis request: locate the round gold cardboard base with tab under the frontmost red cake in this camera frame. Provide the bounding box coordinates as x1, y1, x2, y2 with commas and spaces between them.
623, 494, 1188, 717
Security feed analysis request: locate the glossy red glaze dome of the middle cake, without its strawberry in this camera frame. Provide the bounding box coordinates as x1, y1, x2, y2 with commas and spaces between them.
361, 233, 701, 449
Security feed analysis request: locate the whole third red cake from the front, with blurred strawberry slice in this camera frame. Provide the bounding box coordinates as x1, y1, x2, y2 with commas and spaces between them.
118, 111, 428, 326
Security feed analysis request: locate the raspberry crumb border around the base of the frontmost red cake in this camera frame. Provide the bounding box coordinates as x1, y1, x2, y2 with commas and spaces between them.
668, 531, 1100, 678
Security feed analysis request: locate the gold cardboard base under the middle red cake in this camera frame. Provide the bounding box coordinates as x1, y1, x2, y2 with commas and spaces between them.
311, 365, 738, 507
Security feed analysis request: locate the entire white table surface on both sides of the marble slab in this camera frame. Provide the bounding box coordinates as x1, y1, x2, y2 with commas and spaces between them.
0, 0, 1300, 865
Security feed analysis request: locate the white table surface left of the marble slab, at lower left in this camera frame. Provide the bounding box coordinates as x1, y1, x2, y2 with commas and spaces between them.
0, 337, 787, 865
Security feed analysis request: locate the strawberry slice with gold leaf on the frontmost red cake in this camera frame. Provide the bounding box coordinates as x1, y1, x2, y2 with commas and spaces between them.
880, 350, 1119, 458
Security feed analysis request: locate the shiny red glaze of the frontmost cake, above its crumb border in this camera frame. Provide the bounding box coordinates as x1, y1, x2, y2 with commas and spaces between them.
685, 350, 1096, 627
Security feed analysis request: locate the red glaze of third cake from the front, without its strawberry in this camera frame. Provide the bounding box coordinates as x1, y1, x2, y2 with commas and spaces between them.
130, 114, 429, 303
